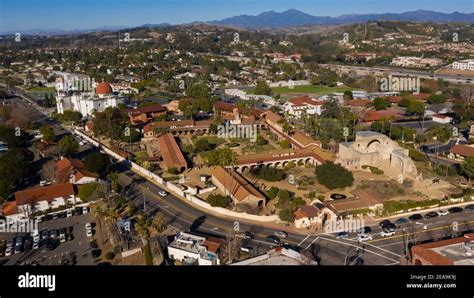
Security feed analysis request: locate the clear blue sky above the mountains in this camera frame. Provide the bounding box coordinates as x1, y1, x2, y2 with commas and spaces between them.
0, 0, 474, 32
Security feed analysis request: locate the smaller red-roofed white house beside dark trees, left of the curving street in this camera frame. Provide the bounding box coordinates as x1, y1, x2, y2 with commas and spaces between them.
55, 157, 99, 184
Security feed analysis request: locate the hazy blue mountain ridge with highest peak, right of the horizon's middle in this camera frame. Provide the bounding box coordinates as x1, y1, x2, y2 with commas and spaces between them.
208, 9, 474, 29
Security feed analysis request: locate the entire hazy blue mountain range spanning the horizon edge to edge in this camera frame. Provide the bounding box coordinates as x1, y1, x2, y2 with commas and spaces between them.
0, 9, 474, 35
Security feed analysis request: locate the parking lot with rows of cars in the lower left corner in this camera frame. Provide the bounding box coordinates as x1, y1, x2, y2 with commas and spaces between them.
0, 207, 97, 265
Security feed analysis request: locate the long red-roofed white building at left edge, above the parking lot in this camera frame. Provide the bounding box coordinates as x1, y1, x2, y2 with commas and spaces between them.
3, 182, 80, 220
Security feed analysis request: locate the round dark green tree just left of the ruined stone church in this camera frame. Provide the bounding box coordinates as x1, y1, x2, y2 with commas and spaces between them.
315, 162, 354, 189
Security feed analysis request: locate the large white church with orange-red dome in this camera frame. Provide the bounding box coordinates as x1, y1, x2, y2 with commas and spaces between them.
56, 73, 124, 116
